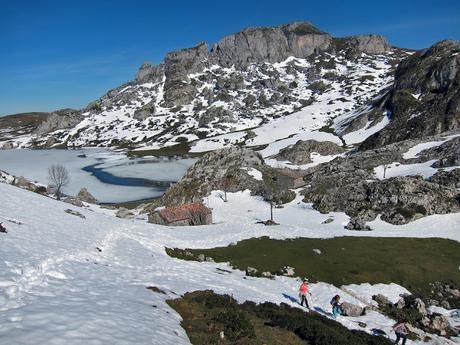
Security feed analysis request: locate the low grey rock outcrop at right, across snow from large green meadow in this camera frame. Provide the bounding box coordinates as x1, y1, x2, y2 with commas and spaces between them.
304, 176, 460, 224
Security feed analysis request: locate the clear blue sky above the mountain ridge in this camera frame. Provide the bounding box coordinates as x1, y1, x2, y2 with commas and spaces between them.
0, 0, 460, 115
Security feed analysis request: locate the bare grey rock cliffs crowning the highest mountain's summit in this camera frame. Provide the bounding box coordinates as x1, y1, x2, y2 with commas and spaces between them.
136, 22, 391, 82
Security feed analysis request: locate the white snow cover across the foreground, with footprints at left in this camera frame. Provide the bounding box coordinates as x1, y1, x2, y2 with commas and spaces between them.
0, 183, 460, 345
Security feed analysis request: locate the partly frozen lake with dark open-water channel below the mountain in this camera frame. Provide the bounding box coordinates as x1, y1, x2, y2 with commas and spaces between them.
0, 148, 195, 203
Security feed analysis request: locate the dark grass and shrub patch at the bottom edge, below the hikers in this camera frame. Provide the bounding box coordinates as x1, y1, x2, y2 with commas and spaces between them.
168, 291, 391, 345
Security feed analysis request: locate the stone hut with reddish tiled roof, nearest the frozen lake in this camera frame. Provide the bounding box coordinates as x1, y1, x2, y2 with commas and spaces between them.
149, 202, 212, 226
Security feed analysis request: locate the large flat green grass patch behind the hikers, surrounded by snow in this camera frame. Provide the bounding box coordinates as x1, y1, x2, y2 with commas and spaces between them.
167, 237, 460, 298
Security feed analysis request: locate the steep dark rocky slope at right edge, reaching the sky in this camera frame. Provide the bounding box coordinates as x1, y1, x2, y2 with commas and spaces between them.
361, 41, 460, 150
